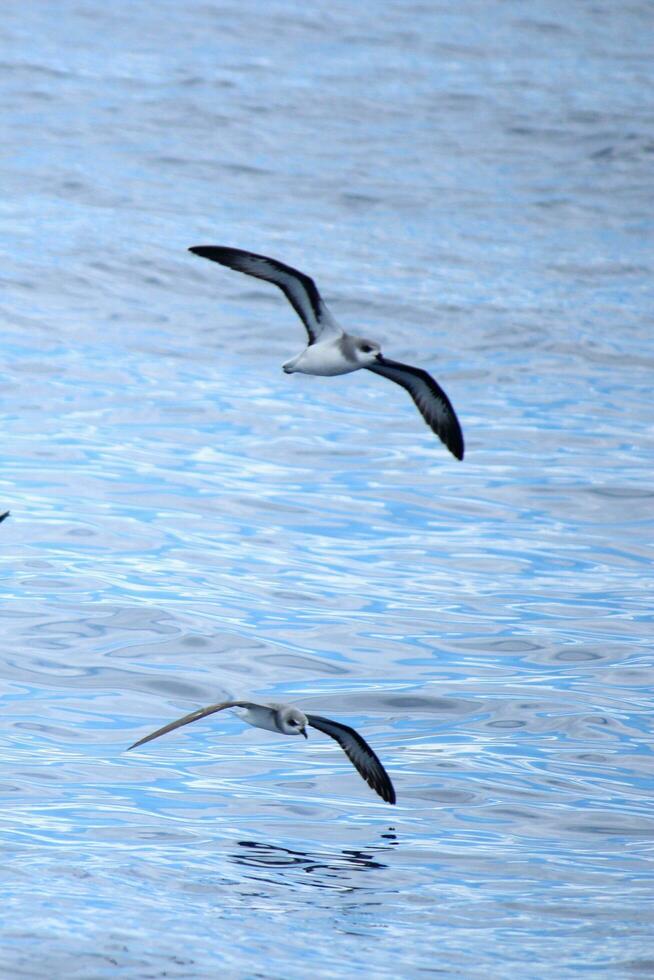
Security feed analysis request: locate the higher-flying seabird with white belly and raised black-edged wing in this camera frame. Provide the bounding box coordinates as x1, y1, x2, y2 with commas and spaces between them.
189, 245, 463, 459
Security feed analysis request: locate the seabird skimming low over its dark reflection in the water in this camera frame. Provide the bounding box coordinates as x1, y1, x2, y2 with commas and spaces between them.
128, 701, 395, 803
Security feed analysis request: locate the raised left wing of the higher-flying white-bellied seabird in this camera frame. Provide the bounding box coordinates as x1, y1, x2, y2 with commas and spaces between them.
189, 245, 341, 345
